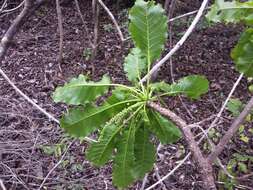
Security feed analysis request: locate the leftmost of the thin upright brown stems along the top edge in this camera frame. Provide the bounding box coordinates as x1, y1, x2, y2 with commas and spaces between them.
56, 0, 64, 64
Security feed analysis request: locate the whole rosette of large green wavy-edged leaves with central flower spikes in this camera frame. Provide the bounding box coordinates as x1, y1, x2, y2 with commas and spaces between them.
53, 0, 209, 188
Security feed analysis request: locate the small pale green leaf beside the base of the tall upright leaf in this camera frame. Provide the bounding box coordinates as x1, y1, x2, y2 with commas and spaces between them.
124, 48, 146, 83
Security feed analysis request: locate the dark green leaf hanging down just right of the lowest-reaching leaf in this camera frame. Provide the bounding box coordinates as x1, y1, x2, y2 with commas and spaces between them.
134, 127, 156, 178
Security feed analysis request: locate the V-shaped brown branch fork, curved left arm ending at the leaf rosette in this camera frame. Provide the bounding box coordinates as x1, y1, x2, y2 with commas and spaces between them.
148, 97, 253, 190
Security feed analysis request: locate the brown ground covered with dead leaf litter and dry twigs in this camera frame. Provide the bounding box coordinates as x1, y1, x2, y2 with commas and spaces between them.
0, 0, 253, 190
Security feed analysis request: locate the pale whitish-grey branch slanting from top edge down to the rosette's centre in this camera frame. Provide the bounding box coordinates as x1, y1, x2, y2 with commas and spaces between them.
140, 0, 209, 83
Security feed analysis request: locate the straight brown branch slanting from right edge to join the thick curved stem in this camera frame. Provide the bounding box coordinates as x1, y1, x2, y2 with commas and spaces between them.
208, 97, 253, 162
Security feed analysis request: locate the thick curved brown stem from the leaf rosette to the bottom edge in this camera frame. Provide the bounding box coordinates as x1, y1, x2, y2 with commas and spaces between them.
148, 102, 216, 190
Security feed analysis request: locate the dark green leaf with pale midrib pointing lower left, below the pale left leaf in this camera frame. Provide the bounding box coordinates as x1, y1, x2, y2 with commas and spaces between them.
61, 90, 135, 137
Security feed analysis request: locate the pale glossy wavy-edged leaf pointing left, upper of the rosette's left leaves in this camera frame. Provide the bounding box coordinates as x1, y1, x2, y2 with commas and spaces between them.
53, 75, 110, 105
